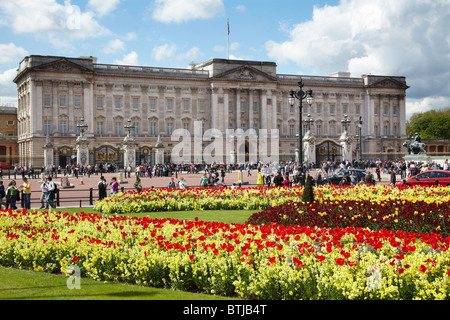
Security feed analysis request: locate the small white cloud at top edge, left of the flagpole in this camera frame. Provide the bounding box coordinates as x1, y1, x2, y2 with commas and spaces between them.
150, 0, 224, 23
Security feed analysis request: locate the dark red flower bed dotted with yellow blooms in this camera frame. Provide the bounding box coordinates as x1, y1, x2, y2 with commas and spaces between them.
248, 199, 450, 236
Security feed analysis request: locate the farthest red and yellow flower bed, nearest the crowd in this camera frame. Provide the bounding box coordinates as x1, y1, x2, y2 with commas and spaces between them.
95, 185, 450, 214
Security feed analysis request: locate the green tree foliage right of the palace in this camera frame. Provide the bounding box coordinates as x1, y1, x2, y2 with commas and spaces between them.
406, 108, 450, 140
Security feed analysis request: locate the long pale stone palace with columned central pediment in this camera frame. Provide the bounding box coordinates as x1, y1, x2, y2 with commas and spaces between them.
14, 55, 408, 168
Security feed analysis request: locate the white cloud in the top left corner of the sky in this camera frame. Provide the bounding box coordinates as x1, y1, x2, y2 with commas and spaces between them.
0, 0, 109, 47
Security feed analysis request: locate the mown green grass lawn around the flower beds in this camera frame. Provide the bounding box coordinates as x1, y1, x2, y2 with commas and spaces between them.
0, 208, 255, 300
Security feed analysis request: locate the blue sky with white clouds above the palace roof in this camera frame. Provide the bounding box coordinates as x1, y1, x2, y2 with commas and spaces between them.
0, 0, 450, 119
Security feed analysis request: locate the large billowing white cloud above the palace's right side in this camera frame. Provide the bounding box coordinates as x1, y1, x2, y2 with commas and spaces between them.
266, 0, 450, 103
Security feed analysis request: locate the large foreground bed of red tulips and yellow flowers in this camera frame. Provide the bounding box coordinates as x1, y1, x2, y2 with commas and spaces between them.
0, 210, 450, 299
